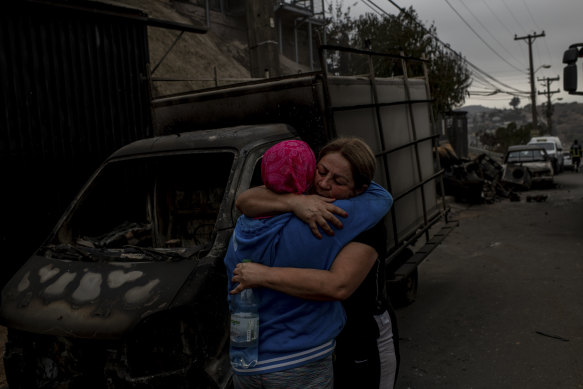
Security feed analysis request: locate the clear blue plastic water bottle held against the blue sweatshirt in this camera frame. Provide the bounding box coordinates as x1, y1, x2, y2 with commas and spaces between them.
230, 261, 259, 369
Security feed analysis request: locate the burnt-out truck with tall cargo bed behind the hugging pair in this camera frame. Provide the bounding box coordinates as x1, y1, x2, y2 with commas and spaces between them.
0, 46, 455, 389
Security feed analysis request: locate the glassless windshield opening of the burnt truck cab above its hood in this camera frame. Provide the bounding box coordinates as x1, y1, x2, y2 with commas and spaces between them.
47, 152, 234, 260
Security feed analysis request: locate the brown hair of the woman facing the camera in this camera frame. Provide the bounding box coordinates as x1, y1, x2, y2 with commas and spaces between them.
318, 137, 377, 190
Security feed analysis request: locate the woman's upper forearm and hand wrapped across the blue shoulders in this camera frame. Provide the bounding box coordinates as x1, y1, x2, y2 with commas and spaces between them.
235, 186, 348, 239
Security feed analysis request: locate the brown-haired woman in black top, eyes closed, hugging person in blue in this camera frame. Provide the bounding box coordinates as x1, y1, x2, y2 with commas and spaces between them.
231, 138, 399, 389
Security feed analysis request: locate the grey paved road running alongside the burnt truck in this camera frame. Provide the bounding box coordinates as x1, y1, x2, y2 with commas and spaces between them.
397, 172, 583, 389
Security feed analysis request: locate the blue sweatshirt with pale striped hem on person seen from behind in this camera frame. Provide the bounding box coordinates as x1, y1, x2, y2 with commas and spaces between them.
225, 182, 393, 375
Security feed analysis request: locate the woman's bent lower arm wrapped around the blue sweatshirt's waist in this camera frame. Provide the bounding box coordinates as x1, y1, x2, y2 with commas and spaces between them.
231, 242, 378, 300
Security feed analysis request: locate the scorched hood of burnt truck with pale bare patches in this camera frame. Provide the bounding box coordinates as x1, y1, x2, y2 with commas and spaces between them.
0, 255, 196, 338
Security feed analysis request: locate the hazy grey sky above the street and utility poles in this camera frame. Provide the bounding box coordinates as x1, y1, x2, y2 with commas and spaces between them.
350, 0, 583, 108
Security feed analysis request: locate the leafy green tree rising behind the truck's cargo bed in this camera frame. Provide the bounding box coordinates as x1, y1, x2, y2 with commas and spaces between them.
327, 2, 471, 113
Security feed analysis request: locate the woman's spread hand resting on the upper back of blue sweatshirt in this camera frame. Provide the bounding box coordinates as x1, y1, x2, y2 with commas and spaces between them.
291, 195, 348, 239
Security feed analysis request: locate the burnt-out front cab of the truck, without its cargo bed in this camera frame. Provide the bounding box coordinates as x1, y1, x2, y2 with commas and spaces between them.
1, 125, 294, 389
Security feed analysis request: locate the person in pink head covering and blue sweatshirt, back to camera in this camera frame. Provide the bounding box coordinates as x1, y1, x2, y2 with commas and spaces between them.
225, 140, 392, 389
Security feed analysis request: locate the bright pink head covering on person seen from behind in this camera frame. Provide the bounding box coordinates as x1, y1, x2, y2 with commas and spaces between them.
261, 140, 316, 194
